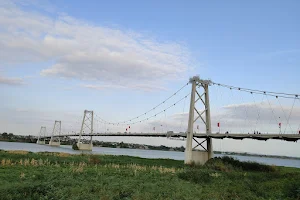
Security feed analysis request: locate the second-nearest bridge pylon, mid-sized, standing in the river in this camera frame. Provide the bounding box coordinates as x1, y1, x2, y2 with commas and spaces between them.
77, 110, 94, 151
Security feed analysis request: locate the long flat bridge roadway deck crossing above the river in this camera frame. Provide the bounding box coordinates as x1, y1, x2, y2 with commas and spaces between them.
41, 133, 300, 141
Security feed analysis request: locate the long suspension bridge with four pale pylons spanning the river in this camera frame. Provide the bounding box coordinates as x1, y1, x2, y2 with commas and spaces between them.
37, 76, 300, 164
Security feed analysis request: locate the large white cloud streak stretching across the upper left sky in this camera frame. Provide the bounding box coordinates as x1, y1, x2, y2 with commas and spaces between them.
0, 1, 191, 90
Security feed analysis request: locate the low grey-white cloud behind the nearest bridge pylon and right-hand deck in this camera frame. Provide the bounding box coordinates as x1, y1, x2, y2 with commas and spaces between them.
134, 101, 300, 133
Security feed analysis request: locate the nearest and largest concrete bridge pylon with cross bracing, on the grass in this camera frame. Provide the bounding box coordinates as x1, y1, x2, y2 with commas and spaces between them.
184, 76, 213, 165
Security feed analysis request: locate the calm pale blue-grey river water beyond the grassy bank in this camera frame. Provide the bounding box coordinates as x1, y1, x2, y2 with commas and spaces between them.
0, 141, 300, 168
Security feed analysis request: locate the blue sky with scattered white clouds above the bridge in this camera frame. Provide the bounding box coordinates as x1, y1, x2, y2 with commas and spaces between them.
0, 0, 300, 157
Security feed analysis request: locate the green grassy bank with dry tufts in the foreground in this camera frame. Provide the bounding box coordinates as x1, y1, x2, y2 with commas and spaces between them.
0, 151, 300, 200
